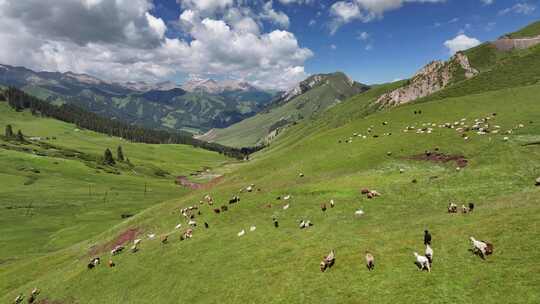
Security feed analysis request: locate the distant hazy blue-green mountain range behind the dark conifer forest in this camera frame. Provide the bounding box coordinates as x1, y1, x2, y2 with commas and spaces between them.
0, 65, 275, 133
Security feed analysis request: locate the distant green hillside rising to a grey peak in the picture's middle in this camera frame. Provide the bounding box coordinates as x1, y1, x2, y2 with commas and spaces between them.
200, 73, 367, 147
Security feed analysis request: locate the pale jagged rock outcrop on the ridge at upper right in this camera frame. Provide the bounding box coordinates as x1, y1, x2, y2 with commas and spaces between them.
376, 52, 478, 107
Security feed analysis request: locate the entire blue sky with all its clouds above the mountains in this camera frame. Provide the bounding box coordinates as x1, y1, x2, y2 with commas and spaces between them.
0, 0, 540, 89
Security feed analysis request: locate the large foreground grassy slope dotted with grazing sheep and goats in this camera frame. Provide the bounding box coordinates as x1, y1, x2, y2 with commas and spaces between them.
0, 85, 540, 303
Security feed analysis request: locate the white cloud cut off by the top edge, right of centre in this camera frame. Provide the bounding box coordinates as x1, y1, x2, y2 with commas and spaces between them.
329, 0, 446, 34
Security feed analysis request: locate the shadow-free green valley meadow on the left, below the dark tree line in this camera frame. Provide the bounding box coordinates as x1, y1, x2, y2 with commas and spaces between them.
0, 103, 230, 269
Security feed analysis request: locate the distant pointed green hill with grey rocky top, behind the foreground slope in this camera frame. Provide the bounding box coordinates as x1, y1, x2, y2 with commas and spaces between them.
202, 75, 368, 147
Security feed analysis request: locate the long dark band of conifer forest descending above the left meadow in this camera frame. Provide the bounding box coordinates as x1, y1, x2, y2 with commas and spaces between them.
3, 87, 263, 159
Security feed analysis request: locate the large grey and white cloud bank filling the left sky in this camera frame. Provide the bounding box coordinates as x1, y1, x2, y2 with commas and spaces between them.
0, 0, 313, 89
